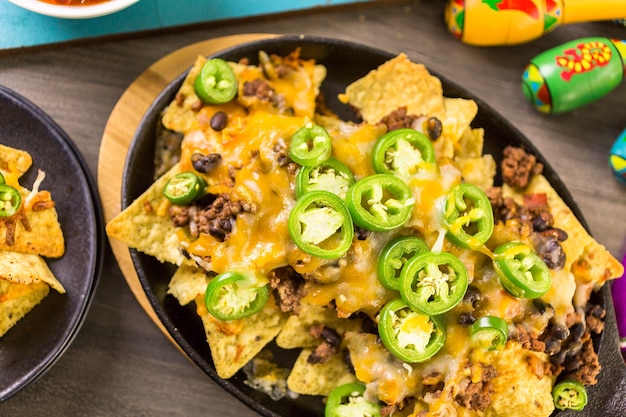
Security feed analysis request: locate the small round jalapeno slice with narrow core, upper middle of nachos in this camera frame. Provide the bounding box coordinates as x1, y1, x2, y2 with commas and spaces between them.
289, 123, 332, 166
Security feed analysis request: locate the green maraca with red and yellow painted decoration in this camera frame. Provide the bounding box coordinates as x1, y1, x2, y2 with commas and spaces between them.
522, 37, 626, 113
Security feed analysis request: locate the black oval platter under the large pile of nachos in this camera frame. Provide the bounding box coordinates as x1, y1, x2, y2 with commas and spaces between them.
122, 36, 626, 417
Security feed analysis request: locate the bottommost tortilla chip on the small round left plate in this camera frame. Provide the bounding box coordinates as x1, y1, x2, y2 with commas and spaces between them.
0, 279, 50, 337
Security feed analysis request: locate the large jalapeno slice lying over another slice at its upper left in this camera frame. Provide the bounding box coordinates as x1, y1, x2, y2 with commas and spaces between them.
400, 252, 469, 315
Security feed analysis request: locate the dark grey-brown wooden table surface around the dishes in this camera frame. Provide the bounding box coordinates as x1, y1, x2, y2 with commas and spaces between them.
0, 0, 626, 417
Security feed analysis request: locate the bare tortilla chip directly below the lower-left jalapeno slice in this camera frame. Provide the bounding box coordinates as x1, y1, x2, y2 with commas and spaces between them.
196, 295, 287, 379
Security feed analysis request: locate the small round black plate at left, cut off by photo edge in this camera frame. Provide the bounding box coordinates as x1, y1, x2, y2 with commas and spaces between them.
0, 86, 104, 402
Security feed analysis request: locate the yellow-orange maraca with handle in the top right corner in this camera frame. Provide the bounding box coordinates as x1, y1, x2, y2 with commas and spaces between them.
445, 0, 626, 46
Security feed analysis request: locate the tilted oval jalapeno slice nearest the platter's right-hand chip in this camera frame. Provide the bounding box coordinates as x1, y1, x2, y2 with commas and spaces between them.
493, 242, 552, 298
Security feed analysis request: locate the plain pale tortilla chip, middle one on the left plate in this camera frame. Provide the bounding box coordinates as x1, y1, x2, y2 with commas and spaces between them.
0, 251, 65, 294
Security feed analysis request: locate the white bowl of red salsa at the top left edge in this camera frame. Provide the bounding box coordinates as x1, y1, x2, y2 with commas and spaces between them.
9, 0, 139, 19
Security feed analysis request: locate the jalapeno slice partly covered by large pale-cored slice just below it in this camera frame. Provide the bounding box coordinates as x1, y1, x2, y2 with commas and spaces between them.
296, 158, 354, 199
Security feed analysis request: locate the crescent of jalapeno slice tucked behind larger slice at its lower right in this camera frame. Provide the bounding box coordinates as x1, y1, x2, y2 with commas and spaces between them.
377, 236, 428, 290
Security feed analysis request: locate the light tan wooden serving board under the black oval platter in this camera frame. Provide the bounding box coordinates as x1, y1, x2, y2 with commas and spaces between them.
97, 34, 276, 341
